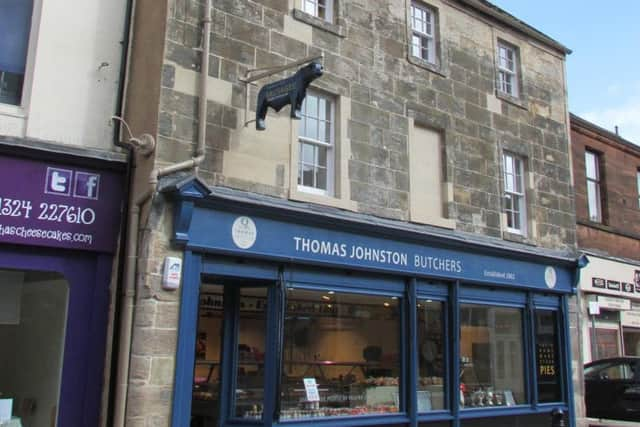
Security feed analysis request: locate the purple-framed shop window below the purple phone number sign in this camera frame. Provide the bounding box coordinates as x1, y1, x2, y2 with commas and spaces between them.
0, 245, 113, 427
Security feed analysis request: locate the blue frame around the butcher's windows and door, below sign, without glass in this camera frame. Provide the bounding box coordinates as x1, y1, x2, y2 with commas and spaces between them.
173, 251, 571, 426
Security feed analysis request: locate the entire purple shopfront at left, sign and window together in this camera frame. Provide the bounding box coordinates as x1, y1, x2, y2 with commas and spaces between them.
0, 154, 126, 427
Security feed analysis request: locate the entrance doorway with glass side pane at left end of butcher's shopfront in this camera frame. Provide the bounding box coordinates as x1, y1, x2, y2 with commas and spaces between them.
191, 280, 273, 427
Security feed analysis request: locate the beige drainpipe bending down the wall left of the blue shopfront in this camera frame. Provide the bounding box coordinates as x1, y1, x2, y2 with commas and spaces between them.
113, 0, 212, 427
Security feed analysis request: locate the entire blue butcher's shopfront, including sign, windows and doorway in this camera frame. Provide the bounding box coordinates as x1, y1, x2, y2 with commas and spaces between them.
165, 179, 576, 427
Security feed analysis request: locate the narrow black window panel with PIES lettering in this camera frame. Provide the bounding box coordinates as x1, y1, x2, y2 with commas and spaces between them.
535, 310, 562, 403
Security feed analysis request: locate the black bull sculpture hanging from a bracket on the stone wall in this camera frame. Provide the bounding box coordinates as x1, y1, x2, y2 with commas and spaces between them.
256, 62, 323, 130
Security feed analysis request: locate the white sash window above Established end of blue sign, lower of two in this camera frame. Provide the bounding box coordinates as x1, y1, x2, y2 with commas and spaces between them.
503, 153, 526, 234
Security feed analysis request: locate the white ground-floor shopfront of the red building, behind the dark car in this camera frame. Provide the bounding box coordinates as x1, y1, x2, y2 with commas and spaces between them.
580, 253, 640, 363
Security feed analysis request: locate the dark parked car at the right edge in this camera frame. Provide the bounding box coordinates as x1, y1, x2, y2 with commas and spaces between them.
584, 357, 640, 421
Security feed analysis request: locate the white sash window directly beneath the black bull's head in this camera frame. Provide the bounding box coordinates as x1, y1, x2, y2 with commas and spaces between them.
298, 91, 335, 196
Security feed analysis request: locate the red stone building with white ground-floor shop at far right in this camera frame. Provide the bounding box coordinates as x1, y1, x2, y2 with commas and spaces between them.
571, 115, 640, 362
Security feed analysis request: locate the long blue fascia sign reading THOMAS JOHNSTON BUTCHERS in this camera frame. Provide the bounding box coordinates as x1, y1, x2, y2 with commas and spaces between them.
181, 207, 572, 292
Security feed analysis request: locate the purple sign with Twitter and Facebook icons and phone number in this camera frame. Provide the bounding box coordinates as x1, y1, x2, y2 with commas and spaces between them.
0, 156, 124, 252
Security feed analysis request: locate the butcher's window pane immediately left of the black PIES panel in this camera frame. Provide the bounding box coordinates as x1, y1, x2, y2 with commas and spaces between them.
459, 304, 526, 408
